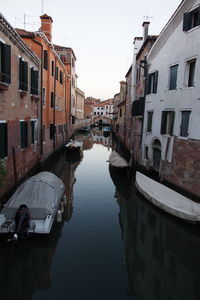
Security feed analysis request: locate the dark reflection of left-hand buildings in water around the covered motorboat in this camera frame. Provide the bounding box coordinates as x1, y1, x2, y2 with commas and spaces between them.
0, 151, 82, 300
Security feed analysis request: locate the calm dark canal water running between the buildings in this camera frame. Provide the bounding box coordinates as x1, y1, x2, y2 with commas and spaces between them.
0, 132, 200, 300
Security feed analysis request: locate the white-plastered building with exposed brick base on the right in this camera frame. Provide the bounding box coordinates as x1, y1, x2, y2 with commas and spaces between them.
142, 0, 200, 196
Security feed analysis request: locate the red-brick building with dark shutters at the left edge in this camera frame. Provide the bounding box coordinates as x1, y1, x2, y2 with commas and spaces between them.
0, 14, 41, 196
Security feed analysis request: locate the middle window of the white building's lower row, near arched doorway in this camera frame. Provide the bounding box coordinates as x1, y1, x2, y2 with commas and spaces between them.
160, 111, 175, 135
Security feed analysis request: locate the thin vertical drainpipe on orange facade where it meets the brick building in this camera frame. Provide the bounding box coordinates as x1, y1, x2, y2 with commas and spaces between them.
32, 36, 43, 155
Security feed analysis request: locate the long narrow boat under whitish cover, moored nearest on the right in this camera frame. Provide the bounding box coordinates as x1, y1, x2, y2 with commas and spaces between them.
135, 172, 200, 222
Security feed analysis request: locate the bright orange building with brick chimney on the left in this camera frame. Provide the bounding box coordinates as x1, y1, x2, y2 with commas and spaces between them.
17, 14, 70, 159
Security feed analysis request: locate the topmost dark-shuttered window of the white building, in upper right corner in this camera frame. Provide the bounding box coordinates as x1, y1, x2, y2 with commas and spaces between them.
183, 6, 200, 31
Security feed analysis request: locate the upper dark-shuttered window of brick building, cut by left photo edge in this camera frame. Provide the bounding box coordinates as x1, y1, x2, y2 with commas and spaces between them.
0, 41, 11, 83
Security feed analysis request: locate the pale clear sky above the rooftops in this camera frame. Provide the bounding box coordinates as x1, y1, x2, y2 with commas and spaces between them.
0, 0, 181, 100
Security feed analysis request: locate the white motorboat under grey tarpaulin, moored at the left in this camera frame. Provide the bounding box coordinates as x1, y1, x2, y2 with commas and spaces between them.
0, 172, 65, 234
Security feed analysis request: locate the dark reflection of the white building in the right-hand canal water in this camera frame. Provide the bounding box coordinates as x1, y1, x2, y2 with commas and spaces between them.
111, 169, 200, 300
